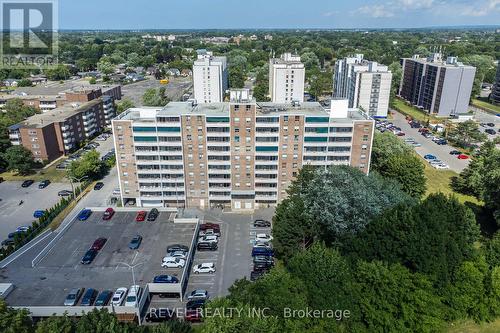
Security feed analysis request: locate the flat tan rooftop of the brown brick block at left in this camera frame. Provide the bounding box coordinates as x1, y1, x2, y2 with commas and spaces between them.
19, 99, 101, 128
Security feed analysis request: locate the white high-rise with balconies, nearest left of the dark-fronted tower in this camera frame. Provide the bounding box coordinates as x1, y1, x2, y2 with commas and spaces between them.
333, 54, 392, 117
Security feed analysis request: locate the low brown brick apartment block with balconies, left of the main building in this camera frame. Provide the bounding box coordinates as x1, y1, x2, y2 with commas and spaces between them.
9, 96, 109, 162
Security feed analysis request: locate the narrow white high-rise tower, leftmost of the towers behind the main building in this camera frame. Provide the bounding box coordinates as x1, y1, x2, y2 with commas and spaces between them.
193, 50, 228, 103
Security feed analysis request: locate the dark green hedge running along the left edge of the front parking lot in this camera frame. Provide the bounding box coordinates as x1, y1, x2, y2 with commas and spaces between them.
0, 182, 90, 260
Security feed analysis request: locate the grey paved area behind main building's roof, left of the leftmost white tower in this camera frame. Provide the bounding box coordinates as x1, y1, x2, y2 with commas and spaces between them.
122, 77, 192, 106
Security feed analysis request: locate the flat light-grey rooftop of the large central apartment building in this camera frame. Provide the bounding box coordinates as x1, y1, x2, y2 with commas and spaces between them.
115, 102, 368, 121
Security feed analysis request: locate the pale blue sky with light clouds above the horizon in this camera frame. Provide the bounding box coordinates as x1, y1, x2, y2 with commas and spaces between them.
59, 0, 500, 29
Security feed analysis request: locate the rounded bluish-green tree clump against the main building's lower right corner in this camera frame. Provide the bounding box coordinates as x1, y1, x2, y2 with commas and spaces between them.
273, 166, 411, 258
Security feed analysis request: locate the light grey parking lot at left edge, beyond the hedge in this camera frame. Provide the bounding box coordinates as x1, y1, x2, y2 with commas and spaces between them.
0, 181, 71, 241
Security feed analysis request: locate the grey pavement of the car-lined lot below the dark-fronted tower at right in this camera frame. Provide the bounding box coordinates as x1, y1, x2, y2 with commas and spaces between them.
391, 110, 469, 173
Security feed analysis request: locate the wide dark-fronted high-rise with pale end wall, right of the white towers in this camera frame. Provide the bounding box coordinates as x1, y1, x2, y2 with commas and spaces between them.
399, 53, 476, 117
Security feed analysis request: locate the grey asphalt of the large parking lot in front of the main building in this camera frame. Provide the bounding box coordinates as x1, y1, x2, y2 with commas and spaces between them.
0, 206, 272, 316
